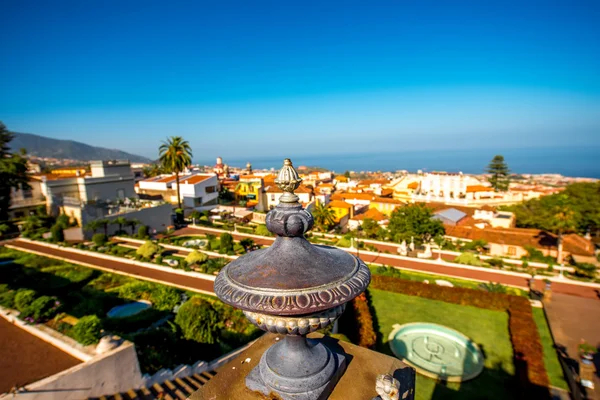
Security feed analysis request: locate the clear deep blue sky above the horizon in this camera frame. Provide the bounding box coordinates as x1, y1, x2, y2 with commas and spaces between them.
0, 0, 600, 159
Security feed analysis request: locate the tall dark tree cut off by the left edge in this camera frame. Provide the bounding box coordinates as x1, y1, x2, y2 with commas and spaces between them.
0, 122, 29, 221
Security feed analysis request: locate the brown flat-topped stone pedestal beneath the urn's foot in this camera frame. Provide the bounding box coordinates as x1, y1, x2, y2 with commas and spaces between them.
190, 333, 415, 400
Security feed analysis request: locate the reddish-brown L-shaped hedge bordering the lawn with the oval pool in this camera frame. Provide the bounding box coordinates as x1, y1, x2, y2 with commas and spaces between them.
370, 275, 550, 398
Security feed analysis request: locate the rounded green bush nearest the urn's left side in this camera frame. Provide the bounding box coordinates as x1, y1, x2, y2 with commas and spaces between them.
175, 297, 221, 344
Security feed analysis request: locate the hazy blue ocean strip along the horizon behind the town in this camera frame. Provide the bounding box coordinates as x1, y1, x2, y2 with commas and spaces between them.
196, 146, 600, 179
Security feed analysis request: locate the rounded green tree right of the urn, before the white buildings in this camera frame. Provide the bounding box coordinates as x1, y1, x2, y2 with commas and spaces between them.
388, 203, 445, 242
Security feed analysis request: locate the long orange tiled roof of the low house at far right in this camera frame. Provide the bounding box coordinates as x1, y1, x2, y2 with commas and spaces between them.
445, 226, 594, 256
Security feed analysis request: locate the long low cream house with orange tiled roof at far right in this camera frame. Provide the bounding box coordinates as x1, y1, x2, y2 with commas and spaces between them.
446, 226, 594, 262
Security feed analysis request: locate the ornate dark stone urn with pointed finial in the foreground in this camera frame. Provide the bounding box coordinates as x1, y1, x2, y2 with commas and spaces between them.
215, 159, 371, 400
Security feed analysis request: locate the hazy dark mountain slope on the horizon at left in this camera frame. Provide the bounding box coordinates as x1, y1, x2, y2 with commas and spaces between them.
10, 133, 151, 162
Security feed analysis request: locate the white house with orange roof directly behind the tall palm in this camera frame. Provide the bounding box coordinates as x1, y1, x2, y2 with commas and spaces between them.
138, 174, 219, 210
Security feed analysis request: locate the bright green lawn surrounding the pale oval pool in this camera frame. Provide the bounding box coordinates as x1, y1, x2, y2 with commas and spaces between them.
370, 289, 516, 400
